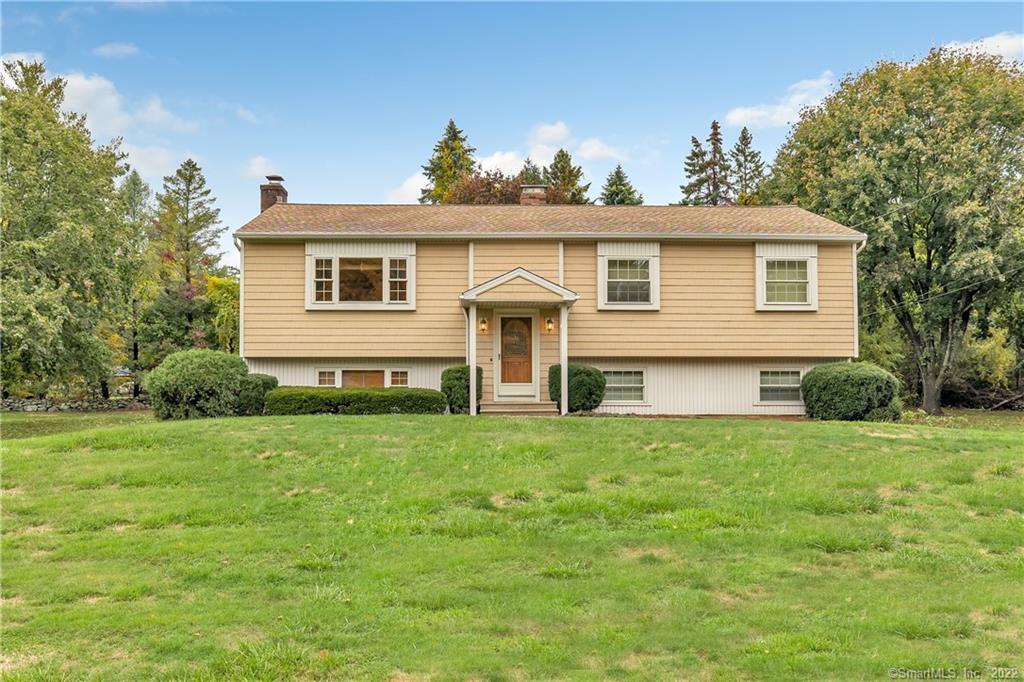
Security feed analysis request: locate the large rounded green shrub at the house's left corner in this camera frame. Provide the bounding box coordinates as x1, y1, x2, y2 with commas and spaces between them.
145, 350, 249, 419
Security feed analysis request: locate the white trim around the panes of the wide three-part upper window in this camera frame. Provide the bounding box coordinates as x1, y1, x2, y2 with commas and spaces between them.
305, 241, 416, 310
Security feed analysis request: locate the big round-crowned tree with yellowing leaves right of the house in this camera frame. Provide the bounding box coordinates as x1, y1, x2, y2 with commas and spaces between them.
765, 49, 1024, 414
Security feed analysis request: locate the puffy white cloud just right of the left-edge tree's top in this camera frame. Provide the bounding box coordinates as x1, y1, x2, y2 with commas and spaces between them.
63, 73, 199, 139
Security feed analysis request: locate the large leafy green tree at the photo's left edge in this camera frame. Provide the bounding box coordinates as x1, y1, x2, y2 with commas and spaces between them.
0, 61, 126, 392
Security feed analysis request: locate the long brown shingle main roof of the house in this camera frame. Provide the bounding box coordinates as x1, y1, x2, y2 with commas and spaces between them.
236, 203, 863, 241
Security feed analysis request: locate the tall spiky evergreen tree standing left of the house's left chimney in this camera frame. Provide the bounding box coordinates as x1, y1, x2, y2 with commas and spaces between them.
155, 159, 226, 346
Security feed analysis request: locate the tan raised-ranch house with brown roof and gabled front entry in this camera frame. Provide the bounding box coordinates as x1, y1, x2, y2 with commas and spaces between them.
236, 176, 865, 415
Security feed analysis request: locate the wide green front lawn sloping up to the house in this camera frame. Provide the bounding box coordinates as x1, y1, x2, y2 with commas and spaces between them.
0, 416, 1024, 680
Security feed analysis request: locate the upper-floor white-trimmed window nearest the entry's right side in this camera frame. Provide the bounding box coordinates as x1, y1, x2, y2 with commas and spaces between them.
597, 242, 660, 310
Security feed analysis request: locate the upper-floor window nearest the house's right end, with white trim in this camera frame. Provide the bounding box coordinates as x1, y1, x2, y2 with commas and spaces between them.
755, 242, 818, 310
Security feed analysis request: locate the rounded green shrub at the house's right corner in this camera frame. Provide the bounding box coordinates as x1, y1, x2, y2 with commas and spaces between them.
800, 363, 902, 421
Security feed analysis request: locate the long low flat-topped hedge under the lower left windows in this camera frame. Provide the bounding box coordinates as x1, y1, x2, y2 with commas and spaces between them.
264, 386, 445, 415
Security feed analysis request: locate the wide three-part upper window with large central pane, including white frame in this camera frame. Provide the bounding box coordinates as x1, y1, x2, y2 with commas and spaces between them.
306, 242, 416, 310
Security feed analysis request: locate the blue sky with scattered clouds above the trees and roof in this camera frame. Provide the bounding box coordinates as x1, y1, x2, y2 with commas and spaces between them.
0, 2, 1024, 263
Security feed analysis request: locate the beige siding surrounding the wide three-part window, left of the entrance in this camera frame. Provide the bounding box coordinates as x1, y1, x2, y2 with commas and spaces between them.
244, 240, 467, 357
